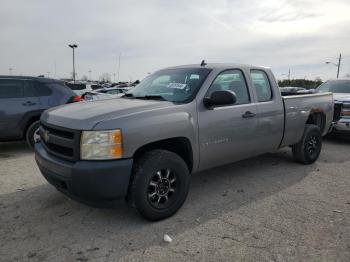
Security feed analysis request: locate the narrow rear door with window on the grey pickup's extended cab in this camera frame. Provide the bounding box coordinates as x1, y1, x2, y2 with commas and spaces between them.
250, 69, 284, 153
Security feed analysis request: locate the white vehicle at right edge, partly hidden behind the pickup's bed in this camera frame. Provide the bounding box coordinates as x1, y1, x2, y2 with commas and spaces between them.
316, 79, 350, 134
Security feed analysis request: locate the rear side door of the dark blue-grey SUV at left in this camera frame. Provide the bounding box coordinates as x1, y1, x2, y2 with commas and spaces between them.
0, 78, 39, 138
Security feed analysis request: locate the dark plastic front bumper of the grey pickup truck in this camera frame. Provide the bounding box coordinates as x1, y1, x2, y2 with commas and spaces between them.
35, 143, 133, 204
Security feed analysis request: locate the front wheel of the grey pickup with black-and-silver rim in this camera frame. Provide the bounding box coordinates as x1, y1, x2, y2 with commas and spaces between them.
128, 150, 190, 221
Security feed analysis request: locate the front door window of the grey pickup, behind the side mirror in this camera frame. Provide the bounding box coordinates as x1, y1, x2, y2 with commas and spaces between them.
208, 69, 250, 105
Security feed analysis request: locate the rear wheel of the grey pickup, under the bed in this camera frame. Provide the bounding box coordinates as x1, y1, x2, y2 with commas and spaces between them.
292, 124, 322, 165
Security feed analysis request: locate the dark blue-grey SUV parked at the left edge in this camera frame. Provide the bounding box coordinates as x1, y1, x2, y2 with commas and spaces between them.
0, 76, 80, 147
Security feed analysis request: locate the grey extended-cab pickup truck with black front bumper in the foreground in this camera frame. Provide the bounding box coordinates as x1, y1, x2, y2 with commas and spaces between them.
35, 63, 333, 220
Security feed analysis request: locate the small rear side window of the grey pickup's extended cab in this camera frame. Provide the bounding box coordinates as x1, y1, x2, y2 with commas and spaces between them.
250, 70, 272, 102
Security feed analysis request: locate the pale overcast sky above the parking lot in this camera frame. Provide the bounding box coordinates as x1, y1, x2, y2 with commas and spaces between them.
0, 0, 350, 80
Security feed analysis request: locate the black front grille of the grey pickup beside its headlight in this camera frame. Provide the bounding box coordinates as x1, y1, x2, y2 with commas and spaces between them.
40, 122, 80, 161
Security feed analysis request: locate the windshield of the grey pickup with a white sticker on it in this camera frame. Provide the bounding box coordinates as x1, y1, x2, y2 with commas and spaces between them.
125, 68, 211, 103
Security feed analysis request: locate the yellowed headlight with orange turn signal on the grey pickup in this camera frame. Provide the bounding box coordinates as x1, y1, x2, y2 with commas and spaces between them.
80, 129, 123, 160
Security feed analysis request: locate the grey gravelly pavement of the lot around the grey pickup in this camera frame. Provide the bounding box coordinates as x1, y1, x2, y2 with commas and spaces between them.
0, 138, 350, 261
